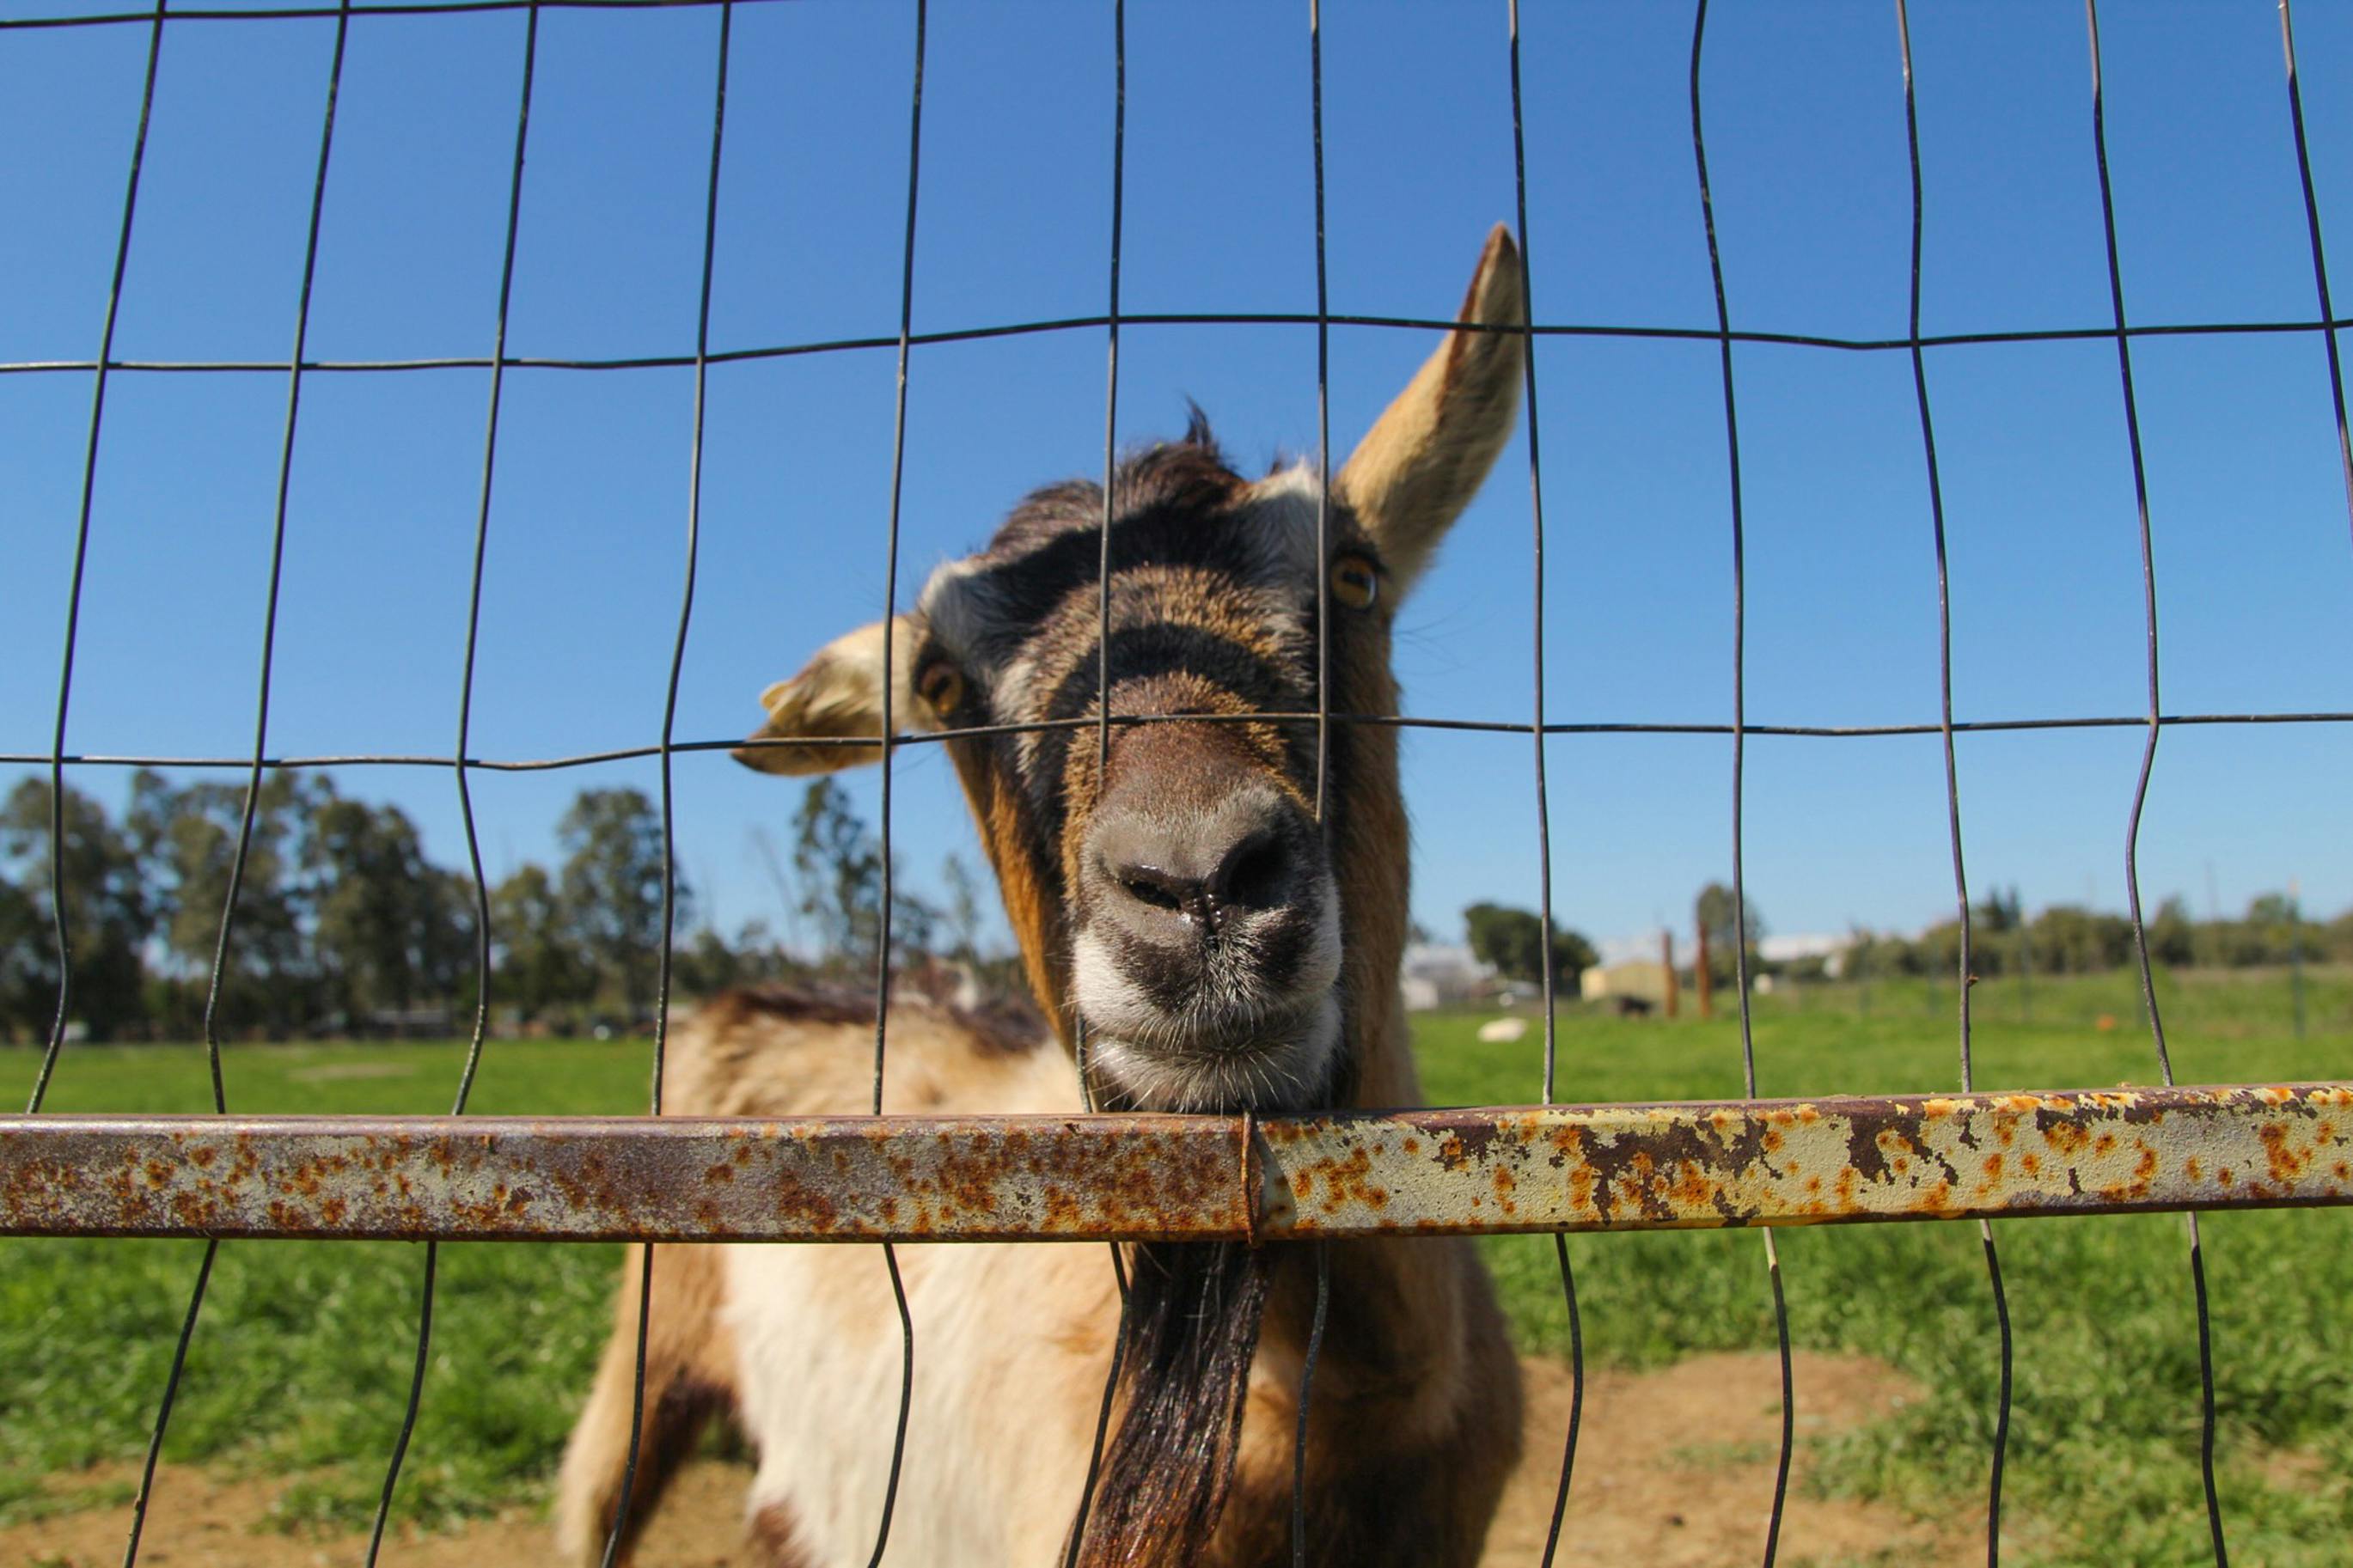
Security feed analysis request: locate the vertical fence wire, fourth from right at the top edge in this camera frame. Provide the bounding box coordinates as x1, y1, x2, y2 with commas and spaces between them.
1692, 0, 1798, 1568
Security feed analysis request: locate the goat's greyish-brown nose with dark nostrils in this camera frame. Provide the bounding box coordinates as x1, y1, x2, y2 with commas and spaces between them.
1094, 797, 1297, 938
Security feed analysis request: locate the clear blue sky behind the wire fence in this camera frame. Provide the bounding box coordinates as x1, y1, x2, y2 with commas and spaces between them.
0, 0, 2353, 963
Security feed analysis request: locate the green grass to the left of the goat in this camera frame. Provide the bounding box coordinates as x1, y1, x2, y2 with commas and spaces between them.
0, 1041, 647, 1528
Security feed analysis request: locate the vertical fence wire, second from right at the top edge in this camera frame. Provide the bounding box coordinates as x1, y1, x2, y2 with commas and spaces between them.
2082, 0, 2231, 1568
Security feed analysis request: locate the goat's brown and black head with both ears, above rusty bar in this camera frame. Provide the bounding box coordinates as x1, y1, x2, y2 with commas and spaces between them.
736, 228, 1525, 1109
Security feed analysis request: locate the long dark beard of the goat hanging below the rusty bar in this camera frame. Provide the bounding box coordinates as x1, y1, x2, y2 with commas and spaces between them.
1078, 1242, 1268, 1568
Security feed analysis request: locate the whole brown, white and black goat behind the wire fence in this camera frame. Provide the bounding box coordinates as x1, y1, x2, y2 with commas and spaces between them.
558, 228, 1525, 1568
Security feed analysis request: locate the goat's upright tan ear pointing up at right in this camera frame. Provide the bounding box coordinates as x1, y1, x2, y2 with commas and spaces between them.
1334, 223, 1527, 590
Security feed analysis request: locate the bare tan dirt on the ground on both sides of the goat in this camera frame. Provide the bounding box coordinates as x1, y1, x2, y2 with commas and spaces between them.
0, 1354, 1983, 1568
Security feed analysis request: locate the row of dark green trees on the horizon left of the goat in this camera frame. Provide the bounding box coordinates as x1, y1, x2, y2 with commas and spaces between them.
0, 769, 1011, 1041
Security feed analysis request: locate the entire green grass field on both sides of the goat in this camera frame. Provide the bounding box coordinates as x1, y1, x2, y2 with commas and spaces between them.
0, 971, 2353, 1565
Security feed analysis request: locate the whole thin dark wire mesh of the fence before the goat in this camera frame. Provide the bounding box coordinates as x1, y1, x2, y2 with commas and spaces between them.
0, 0, 2353, 1568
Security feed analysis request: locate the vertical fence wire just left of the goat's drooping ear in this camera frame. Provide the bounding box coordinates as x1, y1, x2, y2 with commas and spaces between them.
592, 0, 729, 1568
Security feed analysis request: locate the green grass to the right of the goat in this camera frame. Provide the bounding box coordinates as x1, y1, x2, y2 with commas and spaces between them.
1416, 971, 2353, 1568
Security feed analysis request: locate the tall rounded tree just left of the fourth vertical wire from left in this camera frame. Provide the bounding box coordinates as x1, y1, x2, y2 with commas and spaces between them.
555, 790, 689, 1020
